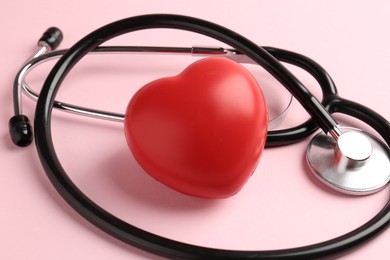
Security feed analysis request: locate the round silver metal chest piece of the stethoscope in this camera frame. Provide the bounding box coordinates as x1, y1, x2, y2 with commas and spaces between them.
307, 128, 390, 195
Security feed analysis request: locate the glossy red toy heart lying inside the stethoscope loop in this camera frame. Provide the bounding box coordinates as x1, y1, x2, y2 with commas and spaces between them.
125, 57, 268, 198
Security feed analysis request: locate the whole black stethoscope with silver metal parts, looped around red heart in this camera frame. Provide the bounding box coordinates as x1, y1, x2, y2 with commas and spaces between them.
10, 15, 390, 259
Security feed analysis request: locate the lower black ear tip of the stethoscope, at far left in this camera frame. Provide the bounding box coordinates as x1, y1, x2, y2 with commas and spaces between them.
9, 115, 33, 147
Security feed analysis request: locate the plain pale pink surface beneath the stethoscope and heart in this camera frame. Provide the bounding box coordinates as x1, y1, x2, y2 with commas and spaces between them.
0, 0, 390, 259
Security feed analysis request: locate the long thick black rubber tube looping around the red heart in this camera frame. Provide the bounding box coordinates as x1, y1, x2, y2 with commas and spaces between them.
34, 15, 390, 259
